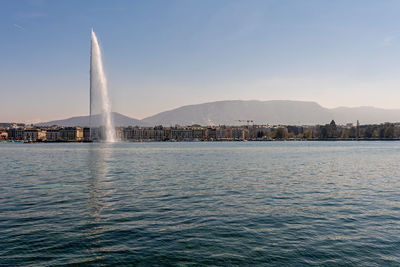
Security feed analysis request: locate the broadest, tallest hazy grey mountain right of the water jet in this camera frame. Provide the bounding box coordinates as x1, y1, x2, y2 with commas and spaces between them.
143, 100, 333, 125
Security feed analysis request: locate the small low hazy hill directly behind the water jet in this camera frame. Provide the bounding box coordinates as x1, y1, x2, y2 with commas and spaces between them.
36, 112, 146, 126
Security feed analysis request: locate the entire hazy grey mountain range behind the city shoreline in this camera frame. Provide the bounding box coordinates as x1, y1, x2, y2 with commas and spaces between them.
36, 100, 400, 126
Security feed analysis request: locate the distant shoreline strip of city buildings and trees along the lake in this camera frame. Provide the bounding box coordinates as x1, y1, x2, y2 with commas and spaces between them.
0, 120, 400, 143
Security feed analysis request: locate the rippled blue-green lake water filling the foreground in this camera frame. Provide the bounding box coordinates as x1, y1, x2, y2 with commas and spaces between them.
0, 142, 400, 266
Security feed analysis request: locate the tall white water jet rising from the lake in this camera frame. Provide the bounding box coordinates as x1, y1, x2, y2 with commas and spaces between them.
90, 29, 115, 142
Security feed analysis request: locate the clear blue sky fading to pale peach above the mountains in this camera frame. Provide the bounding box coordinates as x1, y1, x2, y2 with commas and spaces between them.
0, 0, 400, 123
